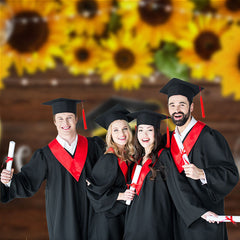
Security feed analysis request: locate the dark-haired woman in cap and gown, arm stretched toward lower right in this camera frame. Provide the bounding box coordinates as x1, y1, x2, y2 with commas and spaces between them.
124, 111, 220, 240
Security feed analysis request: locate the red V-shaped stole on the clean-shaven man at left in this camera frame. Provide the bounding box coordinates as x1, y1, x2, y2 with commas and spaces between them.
48, 135, 88, 181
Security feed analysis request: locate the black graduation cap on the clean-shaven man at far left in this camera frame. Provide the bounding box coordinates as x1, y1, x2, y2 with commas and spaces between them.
43, 98, 82, 114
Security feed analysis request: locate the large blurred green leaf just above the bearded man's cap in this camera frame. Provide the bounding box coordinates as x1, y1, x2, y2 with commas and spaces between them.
154, 44, 189, 81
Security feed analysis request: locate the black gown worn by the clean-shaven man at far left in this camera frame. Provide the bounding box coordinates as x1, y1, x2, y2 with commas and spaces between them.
1, 137, 103, 240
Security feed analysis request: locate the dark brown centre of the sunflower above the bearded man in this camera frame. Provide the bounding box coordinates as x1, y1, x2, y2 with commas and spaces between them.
194, 31, 221, 60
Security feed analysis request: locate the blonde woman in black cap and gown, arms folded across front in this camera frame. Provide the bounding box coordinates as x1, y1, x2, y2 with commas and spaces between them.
88, 104, 137, 240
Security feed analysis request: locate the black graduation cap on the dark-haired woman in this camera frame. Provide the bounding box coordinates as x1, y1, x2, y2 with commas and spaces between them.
128, 109, 169, 128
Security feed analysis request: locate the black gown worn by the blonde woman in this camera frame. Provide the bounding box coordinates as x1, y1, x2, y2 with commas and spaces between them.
87, 153, 127, 240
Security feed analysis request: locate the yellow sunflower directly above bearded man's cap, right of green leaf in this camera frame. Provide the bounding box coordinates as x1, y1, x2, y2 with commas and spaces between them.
178, 15, 229, 81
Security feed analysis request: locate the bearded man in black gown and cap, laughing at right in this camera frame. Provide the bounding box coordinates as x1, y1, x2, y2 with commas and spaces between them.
160, 78, 239, 240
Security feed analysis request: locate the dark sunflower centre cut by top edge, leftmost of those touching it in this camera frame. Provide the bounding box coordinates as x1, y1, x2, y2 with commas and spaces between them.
77, 0, 98, 18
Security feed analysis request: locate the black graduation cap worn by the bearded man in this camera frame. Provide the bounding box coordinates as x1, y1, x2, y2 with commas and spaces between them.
160, 78, 203, 103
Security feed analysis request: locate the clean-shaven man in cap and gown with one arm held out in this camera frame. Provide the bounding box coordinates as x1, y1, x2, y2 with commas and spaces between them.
1, 98, 104, 240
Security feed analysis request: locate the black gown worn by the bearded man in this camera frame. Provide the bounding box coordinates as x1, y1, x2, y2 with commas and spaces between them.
165, 126, 239, 240
